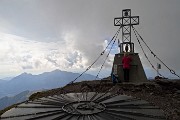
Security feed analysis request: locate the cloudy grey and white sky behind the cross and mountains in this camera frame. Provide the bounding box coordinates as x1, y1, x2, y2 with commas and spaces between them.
0, 0, 180, 78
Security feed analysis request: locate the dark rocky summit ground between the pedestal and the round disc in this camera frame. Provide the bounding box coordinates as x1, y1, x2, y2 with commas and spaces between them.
0, 78, 180, 120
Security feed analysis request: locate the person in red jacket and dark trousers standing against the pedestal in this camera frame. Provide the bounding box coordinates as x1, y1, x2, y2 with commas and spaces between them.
122, 52, 132, 82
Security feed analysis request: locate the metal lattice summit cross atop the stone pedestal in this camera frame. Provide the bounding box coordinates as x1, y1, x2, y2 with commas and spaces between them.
114, 9, 139, 52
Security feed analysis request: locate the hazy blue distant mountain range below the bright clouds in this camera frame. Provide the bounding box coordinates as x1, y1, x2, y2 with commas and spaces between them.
0, 70, 95, 98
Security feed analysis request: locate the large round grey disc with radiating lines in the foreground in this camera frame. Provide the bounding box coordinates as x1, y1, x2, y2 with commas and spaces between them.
1, 92, 165, 120
